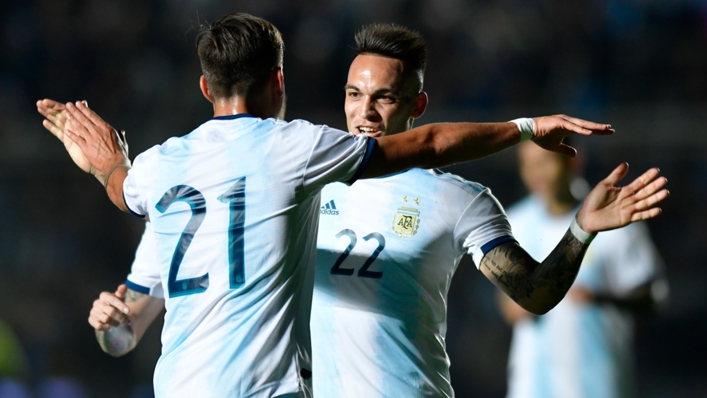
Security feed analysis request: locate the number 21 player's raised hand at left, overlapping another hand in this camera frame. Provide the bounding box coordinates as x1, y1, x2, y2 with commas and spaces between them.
64, 102, 130, 185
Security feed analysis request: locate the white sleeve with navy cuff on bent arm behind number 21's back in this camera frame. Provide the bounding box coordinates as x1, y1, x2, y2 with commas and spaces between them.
125, 222, 164, 298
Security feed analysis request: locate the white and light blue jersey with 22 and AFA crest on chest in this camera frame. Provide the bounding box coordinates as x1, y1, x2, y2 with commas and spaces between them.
311, 169, 513, 398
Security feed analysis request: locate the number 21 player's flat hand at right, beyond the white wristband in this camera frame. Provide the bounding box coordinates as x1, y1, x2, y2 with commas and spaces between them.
531, 115, 614, 157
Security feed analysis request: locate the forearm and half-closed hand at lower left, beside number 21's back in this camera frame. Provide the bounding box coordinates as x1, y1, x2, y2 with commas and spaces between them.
88, 285, 164, 357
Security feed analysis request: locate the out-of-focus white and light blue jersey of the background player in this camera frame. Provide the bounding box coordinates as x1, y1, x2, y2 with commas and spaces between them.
508, 197, 661, 398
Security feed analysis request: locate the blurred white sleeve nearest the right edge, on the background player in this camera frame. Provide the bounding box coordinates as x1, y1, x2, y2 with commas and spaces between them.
592, 222, 663, 296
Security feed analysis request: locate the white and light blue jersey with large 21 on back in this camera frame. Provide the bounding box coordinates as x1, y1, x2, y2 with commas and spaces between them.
123, 115, 375, 397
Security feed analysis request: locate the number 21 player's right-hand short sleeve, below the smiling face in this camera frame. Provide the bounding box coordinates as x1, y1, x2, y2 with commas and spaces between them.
304, 126, 376, 192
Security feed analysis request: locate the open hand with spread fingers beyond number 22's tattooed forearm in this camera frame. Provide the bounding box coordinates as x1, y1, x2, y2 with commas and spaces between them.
577, 163, 670, 233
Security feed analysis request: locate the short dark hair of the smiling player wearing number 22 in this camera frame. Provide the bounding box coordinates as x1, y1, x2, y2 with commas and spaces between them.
356, 23, 427, 89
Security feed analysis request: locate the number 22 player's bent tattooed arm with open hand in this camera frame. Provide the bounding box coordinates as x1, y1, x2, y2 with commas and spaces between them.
479, 163, 668, 314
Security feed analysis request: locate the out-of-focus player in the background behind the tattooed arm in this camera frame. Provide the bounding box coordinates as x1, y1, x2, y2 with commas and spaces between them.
500, 141, 667, 398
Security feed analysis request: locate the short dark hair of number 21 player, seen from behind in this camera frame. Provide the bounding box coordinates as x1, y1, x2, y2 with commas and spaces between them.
196, 13, 285, 98
